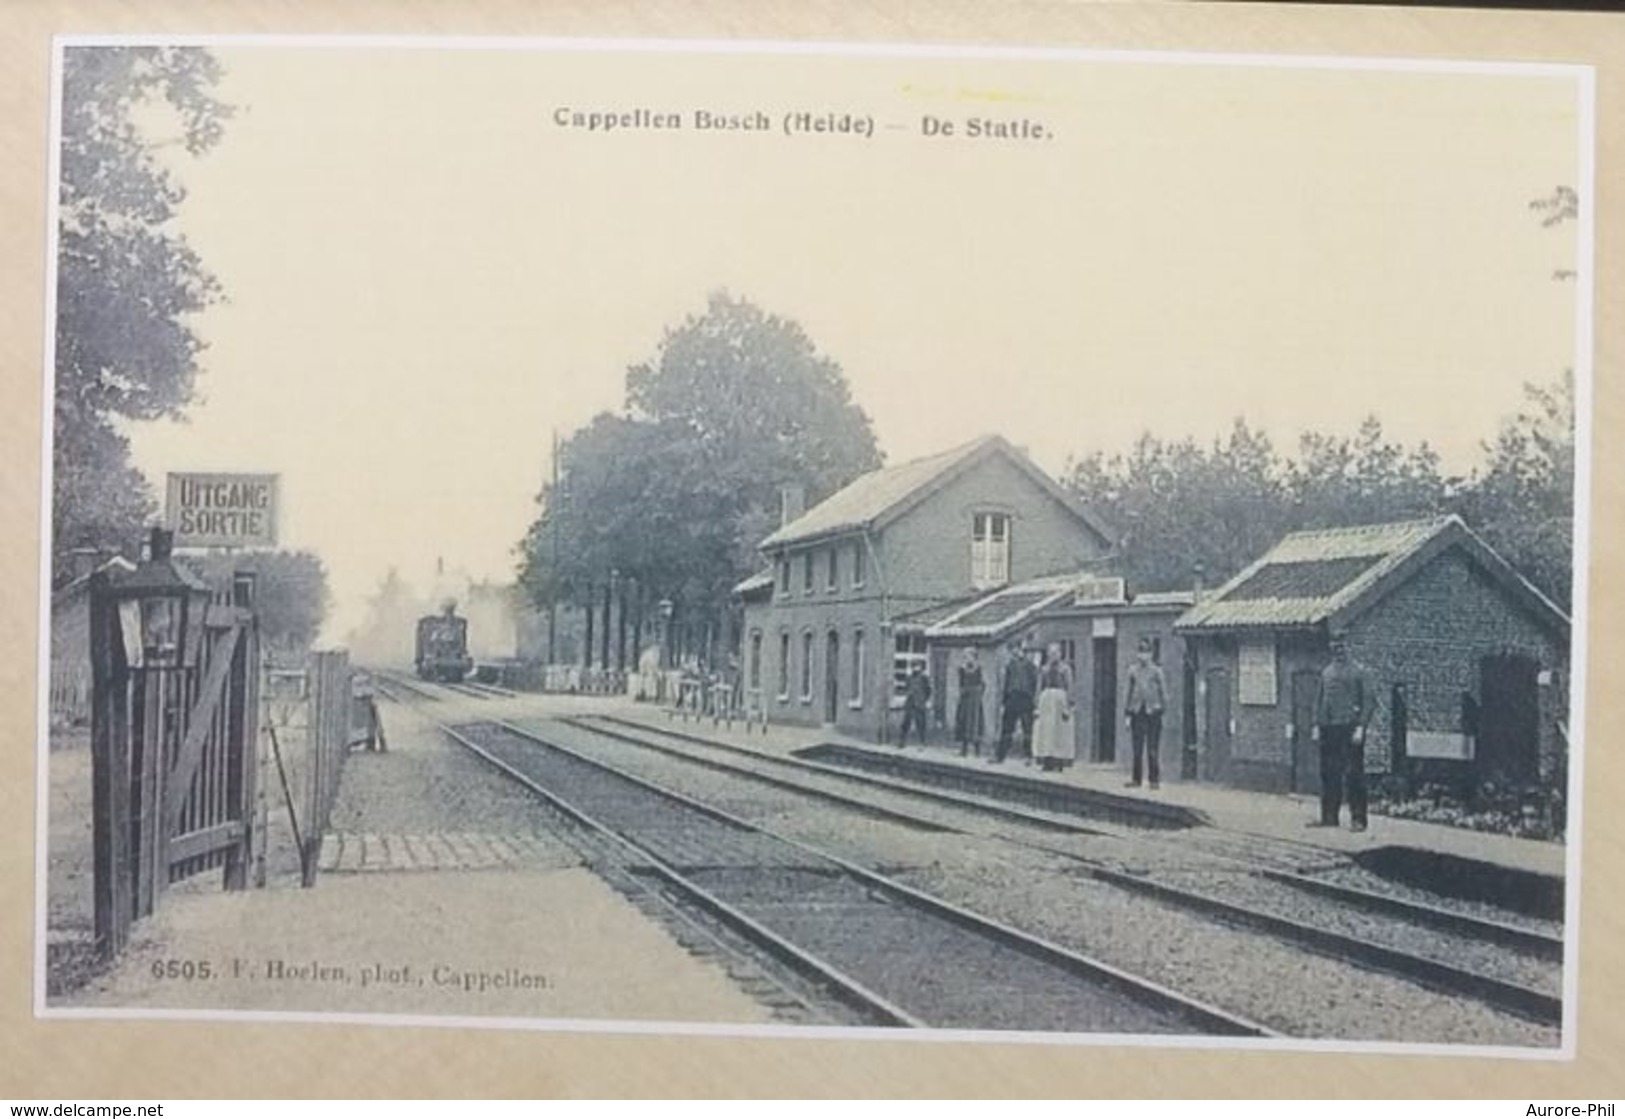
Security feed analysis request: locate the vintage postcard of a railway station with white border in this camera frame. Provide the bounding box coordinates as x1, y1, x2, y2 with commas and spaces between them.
25, 26, 1596, 1084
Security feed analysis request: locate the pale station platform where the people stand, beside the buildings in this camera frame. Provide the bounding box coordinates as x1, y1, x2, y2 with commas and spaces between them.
605, 702, 1567, 879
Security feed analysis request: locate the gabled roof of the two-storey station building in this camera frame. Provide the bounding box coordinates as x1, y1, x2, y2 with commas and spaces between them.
759, 435, 1112, 549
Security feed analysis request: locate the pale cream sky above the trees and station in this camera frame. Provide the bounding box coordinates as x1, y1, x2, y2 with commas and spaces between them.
92, 44, 1580, 640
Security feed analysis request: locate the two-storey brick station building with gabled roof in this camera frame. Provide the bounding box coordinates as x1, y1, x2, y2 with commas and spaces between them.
735, 435, 1115, 741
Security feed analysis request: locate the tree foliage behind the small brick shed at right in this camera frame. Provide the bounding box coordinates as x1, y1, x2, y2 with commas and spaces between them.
1064, 388, 1575, 606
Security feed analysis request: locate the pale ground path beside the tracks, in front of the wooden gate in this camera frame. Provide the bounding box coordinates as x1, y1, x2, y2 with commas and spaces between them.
52, 705, 767, 1023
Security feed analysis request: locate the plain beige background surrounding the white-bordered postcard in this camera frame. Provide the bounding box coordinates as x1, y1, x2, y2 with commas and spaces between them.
0, 0, 1625, 1100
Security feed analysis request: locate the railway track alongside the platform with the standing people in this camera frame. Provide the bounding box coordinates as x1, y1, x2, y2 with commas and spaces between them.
552, 718, 1563, 1026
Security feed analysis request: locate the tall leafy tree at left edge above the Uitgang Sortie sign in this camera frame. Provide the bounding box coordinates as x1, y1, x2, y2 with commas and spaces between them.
52, 47, 231, 573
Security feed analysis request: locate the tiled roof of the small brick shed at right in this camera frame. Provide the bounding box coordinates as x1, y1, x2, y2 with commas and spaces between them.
1177, 516, 1568, 630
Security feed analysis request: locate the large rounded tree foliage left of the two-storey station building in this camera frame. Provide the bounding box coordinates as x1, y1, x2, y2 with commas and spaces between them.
520, 294, 879, 656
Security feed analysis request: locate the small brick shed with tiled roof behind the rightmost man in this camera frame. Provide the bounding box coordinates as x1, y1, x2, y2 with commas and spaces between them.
1175, 516, 1570, 793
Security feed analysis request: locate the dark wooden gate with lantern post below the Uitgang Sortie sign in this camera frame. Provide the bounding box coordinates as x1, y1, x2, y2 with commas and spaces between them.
89, 531, 260, 955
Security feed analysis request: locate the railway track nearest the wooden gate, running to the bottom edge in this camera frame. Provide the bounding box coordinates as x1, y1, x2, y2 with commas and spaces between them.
442, 723, 1271, 1036
